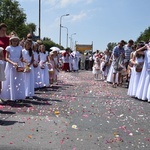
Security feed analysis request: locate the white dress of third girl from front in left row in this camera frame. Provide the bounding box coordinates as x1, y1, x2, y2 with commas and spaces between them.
33, 52, 41, 88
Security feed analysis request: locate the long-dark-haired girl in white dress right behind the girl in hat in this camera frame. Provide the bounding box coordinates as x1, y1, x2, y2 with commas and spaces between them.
22, 39, 34, 99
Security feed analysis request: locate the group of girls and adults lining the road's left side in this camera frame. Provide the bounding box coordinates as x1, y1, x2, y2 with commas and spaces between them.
0, 23, 59, 101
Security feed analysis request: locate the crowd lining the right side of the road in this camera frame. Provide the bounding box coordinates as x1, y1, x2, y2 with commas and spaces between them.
90, 40, 150, 102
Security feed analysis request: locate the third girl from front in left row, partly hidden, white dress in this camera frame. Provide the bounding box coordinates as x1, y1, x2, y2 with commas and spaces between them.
33, 42, 41, 88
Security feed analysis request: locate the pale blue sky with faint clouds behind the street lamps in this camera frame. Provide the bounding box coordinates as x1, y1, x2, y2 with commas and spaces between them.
18, 0, 150, 51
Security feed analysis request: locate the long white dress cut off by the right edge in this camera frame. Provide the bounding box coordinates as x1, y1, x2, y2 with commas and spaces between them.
135, 50, 150, 102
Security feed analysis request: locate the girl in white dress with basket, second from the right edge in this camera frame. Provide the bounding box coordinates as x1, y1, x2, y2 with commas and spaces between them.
128, 53, 144, 97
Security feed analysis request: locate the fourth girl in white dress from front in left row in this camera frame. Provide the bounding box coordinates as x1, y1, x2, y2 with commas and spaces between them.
39, 45, 49, 87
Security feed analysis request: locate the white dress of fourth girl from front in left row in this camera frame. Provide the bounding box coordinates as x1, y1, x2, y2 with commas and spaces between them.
39, 52, 49, 87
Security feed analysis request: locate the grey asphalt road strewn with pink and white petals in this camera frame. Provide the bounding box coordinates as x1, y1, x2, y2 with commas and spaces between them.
0, 71, 150, 150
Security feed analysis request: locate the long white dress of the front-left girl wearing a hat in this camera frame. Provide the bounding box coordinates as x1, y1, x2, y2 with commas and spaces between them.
1, 46, 25, 100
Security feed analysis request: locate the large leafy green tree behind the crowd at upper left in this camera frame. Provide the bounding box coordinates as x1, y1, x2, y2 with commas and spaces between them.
0, 0, 36, 38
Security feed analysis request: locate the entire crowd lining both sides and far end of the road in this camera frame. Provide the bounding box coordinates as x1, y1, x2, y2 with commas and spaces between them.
0, 23, 150, 102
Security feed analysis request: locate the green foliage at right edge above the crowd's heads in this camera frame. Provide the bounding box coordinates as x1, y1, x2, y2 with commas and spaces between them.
136, 27, 150, 43
